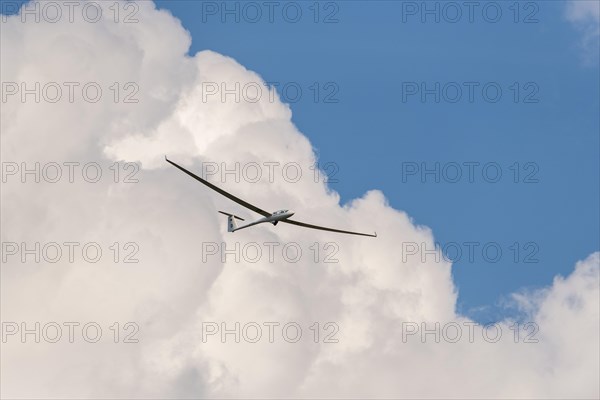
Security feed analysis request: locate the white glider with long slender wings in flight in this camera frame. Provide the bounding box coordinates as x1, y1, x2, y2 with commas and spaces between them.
165, 156, 377, 237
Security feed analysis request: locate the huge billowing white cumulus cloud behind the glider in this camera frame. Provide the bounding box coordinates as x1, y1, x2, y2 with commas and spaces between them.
1, 2, 600, 398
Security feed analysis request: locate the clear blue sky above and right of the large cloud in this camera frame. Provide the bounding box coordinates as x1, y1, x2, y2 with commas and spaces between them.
3, 1, 600, 321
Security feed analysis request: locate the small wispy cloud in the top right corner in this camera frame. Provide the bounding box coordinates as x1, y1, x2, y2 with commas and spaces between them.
566, 0, 600, 64
